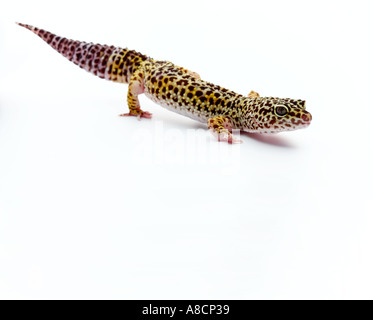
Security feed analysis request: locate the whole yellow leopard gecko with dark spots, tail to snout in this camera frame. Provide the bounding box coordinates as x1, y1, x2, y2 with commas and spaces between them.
18, 23, 312, 143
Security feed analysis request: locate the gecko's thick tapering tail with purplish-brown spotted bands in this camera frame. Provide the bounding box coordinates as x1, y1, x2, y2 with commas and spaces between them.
17, 23, 149, 83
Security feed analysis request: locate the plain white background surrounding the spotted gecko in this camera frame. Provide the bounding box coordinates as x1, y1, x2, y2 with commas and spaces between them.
0, 0, 373, 299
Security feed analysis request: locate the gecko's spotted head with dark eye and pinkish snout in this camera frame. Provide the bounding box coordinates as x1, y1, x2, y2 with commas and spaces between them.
247, 97, 312, 133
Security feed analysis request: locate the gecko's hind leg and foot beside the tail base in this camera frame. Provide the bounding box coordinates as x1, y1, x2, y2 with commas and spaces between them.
120, 67, 152, 119
